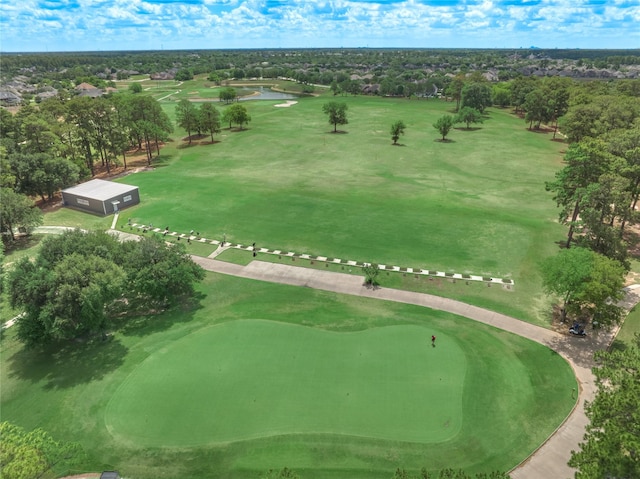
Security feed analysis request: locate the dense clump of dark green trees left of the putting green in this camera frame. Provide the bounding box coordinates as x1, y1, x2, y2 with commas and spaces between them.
8, 230, 204, 345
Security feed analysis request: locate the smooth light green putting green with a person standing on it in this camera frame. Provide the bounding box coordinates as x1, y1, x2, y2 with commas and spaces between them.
105, 320, 467, 446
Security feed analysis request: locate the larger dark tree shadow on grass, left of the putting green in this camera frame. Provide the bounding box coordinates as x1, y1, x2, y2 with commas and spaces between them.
7, 337, 129, 390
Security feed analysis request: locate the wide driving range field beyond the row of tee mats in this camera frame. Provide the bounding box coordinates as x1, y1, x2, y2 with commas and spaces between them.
110, 96, 565, 324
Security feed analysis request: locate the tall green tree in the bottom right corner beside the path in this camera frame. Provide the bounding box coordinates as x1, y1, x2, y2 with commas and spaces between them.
569, 335, 640, 479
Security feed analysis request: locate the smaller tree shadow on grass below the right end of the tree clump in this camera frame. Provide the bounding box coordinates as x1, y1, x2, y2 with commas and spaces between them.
115, 292, 206, 337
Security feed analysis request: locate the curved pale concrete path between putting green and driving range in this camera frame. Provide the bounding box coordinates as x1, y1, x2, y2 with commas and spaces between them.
192, 256, 624, 479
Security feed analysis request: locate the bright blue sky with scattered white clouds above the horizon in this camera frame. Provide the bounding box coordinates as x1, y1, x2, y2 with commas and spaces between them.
0, 0, 640, 52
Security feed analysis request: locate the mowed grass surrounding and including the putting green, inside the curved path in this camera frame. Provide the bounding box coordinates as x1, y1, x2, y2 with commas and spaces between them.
0, 274, 576, 479
